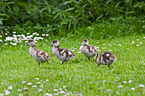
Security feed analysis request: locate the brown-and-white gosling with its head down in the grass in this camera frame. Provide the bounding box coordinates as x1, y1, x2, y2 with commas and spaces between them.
96, 52, 117, 69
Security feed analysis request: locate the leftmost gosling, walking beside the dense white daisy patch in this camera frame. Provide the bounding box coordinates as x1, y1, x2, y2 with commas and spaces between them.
26, 39, 51, 65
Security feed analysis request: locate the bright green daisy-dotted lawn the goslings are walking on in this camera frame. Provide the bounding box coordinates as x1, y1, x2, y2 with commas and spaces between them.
0, 35, 145, 96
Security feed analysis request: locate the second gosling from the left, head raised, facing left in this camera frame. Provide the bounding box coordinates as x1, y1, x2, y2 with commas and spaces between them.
50, 40, 75, 64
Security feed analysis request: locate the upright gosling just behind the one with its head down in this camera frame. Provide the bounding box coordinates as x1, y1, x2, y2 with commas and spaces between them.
80, 39, 98, 59
